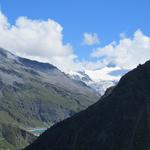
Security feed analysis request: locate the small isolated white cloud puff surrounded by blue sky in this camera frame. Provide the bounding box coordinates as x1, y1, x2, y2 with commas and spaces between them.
83, 33, 100, 45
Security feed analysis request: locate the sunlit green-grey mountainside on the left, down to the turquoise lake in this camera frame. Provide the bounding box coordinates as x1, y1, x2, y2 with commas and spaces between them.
0, 48, 99, 150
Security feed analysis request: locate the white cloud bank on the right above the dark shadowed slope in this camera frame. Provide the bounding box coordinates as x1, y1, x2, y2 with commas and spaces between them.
91, 30, 150, 69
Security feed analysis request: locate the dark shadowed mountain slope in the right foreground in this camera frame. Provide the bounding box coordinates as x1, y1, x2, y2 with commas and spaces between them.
25, 61, 150, 150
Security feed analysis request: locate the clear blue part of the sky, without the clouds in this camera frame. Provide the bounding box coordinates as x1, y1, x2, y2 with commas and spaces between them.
0, 0, 150, 72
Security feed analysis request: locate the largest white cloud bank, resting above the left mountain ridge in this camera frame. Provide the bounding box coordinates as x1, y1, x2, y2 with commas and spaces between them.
0, 12, 81, 71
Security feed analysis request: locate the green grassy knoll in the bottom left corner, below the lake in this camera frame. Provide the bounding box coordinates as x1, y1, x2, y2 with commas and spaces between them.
0, 124, 36, 150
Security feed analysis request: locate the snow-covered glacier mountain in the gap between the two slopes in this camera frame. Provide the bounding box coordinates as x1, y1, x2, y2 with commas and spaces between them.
68, 67, 129, 95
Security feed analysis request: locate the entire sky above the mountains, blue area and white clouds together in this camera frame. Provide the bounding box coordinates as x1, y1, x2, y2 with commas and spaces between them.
0, 0, 150, 71
